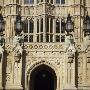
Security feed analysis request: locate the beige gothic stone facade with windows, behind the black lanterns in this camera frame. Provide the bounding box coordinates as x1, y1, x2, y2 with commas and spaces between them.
0, 0, 90, 90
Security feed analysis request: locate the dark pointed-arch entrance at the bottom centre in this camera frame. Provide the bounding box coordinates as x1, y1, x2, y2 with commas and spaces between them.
29, 64, 57, 90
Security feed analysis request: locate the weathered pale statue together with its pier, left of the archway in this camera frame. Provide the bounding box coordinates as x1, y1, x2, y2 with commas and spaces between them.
12, 35, 23, 85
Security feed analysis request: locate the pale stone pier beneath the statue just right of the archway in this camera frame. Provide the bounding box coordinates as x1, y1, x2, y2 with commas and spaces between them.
65, 52, 76, 90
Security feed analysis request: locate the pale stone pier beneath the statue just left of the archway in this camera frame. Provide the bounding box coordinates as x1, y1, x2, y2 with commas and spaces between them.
13, 53, 23, 90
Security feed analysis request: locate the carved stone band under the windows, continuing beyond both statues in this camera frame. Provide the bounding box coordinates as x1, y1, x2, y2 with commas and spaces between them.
5, 43, 82, 52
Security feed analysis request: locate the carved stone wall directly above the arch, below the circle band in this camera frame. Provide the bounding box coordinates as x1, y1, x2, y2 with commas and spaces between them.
26, 51, 64, 68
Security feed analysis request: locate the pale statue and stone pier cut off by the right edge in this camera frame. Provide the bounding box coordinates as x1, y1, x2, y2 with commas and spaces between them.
82, 35, 90, 90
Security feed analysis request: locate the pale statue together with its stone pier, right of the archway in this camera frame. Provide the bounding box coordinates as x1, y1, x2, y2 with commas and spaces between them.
65, 36, 76, 90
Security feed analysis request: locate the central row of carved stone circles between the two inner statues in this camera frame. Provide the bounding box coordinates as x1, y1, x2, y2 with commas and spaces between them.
24, 43, 64, 51
